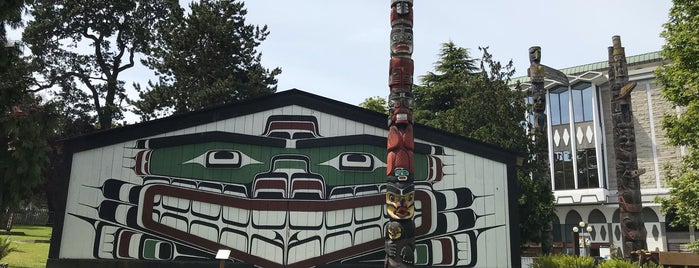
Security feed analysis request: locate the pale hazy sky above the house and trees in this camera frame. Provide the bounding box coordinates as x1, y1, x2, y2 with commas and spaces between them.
5, 0, 672, 119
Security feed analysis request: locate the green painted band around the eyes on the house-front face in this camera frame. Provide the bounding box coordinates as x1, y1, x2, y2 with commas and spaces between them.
150, 142, 428, 186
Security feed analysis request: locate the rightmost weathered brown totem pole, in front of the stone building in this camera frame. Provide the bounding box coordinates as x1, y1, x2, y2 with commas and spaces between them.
609, 35, 646, 258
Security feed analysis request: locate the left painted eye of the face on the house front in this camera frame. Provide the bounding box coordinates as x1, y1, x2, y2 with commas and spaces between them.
182, 149, 262, 168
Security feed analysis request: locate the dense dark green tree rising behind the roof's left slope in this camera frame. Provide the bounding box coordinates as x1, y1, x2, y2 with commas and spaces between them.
134, 0, 281, 119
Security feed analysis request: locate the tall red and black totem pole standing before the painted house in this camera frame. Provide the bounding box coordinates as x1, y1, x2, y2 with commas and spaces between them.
385, 0, 415, 267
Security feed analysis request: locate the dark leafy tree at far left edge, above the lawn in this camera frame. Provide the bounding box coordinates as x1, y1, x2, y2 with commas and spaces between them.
0, 39, 56, 218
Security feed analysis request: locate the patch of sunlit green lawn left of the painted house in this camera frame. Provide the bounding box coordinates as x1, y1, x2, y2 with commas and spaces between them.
0, 225, 51, 268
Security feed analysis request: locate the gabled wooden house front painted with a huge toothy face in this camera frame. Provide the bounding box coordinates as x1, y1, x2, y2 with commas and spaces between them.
48, 90, 520, 267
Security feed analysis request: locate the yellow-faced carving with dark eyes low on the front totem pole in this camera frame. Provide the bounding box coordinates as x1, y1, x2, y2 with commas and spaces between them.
386, 183, 415, 220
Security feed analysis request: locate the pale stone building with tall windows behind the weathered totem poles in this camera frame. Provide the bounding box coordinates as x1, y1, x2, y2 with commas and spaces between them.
515, 52, 696, 255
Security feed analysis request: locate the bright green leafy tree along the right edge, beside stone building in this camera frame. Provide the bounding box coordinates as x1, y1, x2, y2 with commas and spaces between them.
656, 0, 699, 251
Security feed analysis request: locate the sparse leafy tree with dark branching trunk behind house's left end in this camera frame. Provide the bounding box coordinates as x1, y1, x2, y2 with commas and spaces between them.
23, 0, 179, 129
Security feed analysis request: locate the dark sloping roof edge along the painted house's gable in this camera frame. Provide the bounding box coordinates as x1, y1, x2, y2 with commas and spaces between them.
65, 89, 516, 165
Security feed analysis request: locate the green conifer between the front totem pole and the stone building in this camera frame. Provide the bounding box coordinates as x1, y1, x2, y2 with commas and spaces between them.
413, 42, 554, 245
